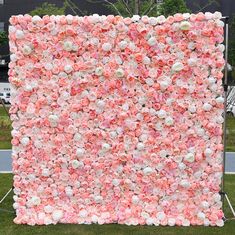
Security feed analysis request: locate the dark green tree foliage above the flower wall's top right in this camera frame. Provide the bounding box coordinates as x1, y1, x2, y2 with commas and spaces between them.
160, 0, 190, 17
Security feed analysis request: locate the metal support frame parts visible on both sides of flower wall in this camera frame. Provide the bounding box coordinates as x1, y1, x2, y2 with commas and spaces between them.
0, 16, 235, 221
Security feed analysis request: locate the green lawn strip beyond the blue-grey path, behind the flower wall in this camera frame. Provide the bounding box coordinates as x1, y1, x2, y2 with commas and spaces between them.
0, 107, 235, 151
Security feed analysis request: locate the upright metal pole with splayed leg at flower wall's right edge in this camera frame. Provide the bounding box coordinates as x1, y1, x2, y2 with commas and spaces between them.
220, 16, 235, 221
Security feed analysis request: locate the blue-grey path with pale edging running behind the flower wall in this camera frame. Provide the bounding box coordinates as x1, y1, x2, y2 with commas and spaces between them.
0, 150, 235, 174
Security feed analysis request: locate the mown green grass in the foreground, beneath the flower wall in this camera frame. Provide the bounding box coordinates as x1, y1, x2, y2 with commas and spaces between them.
0, 174, 235, 235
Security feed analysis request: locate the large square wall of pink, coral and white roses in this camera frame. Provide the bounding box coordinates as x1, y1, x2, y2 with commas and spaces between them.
9, 12, 224, 226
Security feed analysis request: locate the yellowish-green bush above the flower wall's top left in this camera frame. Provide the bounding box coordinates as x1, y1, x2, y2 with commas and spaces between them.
29, 2, 66, 16
